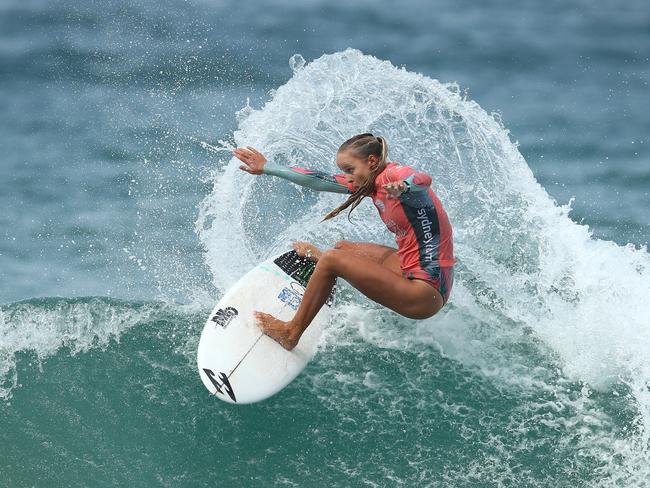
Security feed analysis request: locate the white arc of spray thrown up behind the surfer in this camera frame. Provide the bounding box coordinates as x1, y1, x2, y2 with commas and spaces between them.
197, 50, 650, 482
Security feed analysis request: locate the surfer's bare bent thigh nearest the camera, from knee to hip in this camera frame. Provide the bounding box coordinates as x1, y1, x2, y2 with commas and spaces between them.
317, 249, 442, 319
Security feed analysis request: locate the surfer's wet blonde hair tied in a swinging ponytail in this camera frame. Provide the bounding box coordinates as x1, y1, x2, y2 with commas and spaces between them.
321, 133, 388, 222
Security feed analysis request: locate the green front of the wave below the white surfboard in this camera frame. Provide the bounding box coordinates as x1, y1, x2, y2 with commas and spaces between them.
0, 298, 635, 486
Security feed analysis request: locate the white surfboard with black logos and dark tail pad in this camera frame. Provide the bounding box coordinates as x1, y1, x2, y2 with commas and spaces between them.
197, 251, 333, 403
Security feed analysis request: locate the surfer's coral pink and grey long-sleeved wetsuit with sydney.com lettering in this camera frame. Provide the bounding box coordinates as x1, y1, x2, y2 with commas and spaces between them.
264, 163, 455, 303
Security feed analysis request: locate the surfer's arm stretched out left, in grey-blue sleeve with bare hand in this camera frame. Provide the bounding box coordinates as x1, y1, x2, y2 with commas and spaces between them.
233, 147, 353, 193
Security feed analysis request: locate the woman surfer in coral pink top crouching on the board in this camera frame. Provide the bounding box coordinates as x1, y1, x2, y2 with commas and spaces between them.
233, 134, 454, 350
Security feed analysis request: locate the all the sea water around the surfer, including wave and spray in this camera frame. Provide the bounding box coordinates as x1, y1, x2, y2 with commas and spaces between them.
0, 0, 650, 488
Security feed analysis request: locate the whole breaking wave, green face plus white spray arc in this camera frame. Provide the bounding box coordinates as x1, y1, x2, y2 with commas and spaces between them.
0, 50, 650, 488
